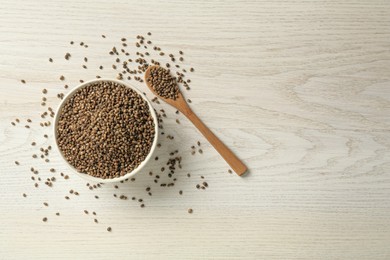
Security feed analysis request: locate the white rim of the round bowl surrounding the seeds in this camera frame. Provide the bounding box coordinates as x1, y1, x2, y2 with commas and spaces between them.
53, 78, 158, 183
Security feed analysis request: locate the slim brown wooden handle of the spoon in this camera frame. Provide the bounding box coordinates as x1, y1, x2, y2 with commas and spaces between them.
183, 106, 247, 176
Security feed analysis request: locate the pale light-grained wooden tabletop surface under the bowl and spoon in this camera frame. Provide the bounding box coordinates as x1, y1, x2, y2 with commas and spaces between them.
0, 0, 390, 259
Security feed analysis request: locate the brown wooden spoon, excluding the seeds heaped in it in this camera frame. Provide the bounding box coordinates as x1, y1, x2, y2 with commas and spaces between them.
145, 66, 247, 176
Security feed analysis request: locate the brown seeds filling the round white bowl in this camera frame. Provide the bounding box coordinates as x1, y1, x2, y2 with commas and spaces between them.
56, 81, 155, 179
